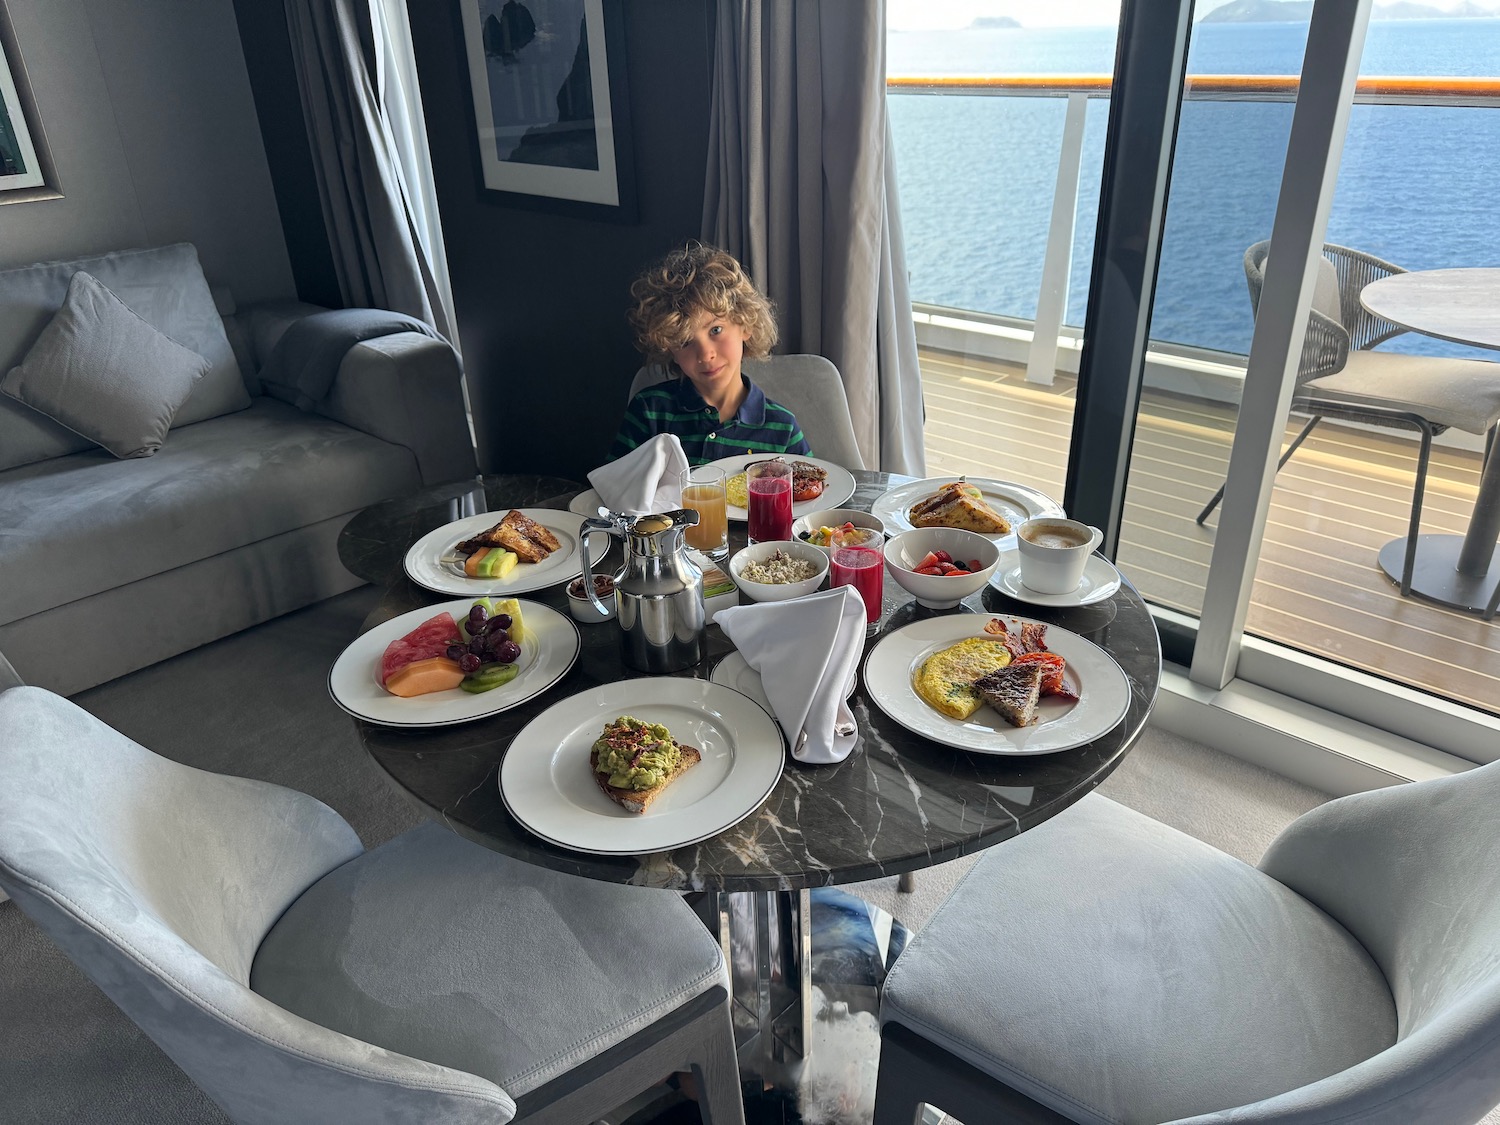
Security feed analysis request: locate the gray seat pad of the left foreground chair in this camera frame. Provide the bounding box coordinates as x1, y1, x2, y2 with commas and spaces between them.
251, 824, 728, 1097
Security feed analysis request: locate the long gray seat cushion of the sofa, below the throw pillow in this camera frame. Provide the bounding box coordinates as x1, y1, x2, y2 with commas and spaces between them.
0, 399, 422, 623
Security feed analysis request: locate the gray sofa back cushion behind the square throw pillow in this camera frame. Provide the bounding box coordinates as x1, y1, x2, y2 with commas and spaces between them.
0, 243, 251, 470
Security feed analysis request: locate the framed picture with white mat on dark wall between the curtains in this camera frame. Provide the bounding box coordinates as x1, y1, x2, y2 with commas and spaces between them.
459, 0, 635, 222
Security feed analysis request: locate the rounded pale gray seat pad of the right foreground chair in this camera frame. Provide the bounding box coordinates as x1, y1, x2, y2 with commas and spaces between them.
881, 795, 1397, 1125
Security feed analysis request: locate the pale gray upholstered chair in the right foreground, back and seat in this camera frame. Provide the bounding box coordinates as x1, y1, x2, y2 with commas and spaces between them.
875, 764, 1500, 1125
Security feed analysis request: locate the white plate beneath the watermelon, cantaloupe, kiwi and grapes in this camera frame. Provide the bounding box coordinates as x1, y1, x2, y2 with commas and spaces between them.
329, 599, 579, 726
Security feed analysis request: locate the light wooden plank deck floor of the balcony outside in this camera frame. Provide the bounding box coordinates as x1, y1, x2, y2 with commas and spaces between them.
921, 350, 1500, 713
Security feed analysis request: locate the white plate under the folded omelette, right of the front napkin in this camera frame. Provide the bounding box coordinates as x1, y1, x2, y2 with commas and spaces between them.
864, 614, 1130, 755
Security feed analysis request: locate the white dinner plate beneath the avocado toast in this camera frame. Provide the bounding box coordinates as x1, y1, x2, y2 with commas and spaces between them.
500, 677, 786, 855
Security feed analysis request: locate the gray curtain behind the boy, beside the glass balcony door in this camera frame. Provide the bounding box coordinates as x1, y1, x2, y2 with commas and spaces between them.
704, 0, 926, 476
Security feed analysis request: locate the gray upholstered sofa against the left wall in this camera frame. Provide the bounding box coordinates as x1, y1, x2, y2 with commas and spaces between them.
0, 243, 476, 695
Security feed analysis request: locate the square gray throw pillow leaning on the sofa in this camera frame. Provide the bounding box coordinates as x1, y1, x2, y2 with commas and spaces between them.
0, 270, 209, 458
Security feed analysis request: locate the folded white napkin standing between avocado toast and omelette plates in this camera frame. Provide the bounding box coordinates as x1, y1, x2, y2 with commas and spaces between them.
714, 587, 866, 765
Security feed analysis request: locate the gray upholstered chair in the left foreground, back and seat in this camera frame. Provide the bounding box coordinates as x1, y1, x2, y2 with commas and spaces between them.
0, 687, 744, 1125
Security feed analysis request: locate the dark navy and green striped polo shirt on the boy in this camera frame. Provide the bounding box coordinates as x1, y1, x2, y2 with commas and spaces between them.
609, 375, 812, 465
